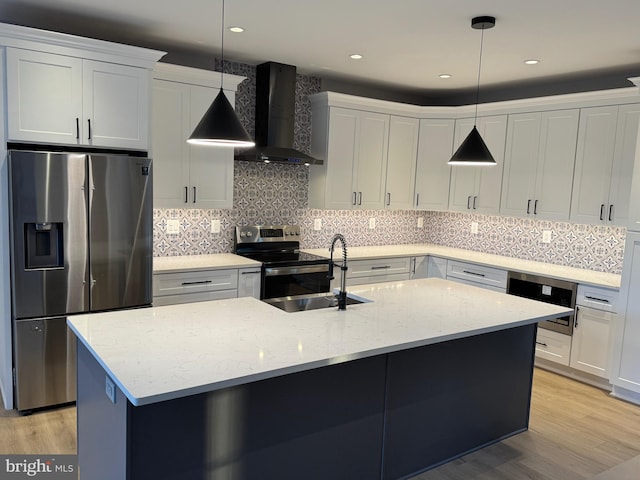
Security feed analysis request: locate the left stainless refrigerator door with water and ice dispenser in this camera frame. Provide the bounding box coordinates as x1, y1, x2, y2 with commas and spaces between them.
9, 151, 89, 318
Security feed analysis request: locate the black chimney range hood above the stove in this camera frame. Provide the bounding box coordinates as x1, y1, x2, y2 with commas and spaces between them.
235, 62, 322, 165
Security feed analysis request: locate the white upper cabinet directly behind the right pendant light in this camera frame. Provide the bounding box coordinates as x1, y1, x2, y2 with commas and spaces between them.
449, 115, 507, 214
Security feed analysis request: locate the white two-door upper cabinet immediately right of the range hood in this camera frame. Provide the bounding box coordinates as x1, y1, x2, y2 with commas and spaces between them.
309, 107, 390, 209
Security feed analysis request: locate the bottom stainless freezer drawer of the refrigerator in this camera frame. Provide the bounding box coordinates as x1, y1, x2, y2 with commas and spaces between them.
13, 317, 76, 410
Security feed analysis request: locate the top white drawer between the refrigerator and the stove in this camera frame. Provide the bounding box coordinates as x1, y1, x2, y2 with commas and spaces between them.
153, 269, 238, 298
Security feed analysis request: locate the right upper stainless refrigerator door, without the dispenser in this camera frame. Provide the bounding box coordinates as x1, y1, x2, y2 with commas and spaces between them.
89, 154, 153, 311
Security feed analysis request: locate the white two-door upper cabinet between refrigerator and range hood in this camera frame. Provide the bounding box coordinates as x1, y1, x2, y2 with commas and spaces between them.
151, 64, 242, 209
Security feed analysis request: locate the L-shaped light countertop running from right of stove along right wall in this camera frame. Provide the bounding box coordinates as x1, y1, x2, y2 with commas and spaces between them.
304, 244, 620, 289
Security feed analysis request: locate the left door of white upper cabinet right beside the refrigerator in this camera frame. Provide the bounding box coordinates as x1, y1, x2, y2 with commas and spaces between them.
151, 80, 190, 208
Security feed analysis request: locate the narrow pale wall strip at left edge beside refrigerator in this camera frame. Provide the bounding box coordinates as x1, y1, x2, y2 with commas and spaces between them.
0, 47, 13, 410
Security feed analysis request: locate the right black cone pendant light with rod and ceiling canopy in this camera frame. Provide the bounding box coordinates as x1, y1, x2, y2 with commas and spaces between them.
449, 16, 496, 165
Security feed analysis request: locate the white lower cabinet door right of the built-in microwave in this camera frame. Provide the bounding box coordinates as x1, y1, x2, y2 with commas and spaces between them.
569, 307, 615, 378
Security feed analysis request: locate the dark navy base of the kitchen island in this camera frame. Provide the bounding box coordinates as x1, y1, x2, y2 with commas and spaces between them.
77, 323, 536, 480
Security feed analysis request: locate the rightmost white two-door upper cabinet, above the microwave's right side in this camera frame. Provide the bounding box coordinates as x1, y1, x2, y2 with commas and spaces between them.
571, 104, 640, 225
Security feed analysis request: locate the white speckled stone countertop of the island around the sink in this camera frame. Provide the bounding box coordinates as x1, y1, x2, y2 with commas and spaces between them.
67, 278, 571, 405
